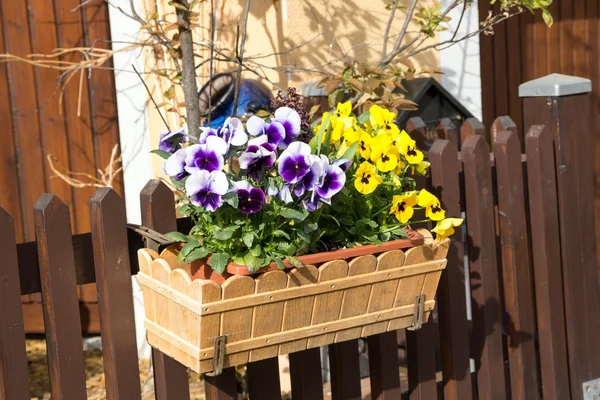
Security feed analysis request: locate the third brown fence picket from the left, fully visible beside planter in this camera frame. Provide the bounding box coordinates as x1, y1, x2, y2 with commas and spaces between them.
90, 188, 141, 400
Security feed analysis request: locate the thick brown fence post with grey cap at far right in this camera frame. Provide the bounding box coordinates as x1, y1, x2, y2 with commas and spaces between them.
519, 74, 600, 399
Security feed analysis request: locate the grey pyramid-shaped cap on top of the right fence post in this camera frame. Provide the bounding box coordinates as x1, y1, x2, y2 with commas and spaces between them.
519, 74, 592, 97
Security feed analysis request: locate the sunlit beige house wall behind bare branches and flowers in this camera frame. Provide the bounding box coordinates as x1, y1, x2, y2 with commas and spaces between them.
140, 0, 440, 175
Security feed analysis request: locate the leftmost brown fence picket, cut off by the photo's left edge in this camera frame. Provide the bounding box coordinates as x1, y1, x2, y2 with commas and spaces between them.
0, 208, 31, 400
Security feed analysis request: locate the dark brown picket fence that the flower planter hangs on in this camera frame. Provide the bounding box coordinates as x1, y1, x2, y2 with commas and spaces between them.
0, 82, 600, 400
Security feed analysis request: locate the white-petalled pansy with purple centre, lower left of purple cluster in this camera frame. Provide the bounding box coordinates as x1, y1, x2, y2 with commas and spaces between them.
185, 169, 229, 212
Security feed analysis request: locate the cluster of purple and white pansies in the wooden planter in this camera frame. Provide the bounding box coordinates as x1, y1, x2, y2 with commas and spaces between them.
161, 107, 351, 214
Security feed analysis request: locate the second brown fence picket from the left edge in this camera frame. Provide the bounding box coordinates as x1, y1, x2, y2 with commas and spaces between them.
34, 194, 87, 400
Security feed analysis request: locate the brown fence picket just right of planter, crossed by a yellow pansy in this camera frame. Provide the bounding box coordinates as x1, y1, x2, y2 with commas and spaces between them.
429, 140, 472, 400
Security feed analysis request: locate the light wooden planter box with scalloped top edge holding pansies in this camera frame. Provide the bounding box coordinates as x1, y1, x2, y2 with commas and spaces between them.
138, 231, 449, 374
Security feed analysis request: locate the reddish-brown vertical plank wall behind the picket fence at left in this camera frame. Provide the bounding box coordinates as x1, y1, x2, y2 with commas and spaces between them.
0, 0, 123, 333
